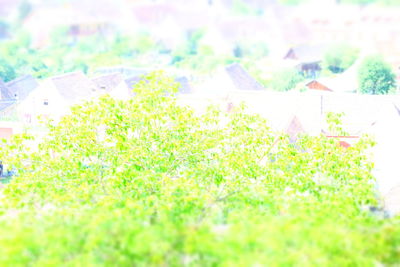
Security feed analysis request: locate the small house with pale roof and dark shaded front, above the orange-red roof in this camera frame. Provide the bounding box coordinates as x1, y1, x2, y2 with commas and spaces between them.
283, 44, 327, 78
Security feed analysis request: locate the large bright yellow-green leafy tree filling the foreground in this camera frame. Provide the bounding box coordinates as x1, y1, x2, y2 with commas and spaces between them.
0, 73, 400, 266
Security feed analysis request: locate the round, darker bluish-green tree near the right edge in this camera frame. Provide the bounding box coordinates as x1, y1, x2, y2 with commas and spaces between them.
358, 56, 396, 95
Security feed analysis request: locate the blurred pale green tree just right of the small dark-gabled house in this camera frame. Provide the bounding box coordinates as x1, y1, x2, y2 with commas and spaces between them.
323, 44, 359, 73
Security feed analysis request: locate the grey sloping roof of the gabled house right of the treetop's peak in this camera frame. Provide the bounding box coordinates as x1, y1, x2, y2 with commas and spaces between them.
225, 63, 264, 90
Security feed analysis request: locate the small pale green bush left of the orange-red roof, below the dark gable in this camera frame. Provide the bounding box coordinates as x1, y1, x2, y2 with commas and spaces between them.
269, 68, 304, 92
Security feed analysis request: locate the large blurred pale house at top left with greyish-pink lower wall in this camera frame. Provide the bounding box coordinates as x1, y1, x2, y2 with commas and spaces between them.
23, 0, 126, 47
